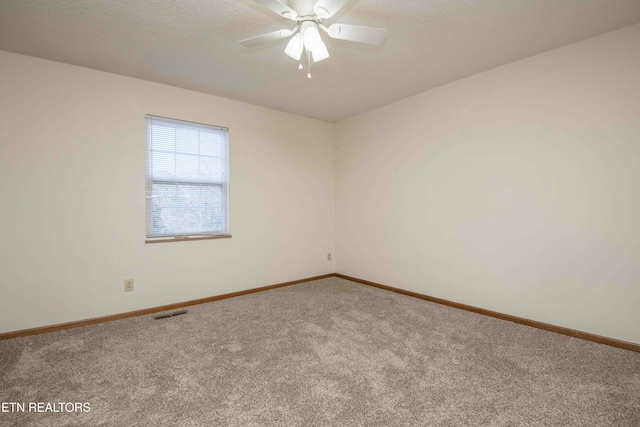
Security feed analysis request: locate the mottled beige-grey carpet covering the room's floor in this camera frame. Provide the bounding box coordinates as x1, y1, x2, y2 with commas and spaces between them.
0, 278, 640, 427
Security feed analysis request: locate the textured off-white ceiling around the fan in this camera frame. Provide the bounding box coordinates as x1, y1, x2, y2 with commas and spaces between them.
0, 0, 640, 121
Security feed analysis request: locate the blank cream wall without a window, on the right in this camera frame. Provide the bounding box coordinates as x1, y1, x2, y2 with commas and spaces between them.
336, 25, 640, 343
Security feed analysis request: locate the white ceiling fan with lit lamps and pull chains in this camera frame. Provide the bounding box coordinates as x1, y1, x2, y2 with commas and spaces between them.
240, 0, 387, 78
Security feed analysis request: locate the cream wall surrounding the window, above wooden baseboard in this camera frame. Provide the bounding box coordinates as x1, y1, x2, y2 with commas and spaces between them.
0, 52, 335, 332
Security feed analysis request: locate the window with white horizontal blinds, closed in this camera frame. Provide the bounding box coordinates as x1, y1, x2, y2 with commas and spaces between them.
146, 116, 229, 238
